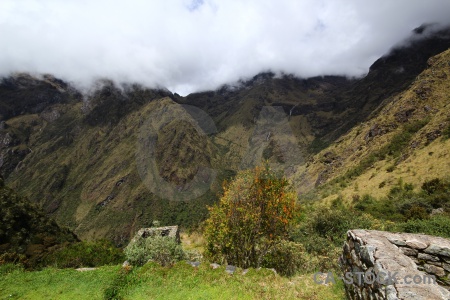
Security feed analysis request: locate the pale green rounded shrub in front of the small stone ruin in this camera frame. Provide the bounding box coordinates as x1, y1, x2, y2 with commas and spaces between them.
124, 236, 185, 266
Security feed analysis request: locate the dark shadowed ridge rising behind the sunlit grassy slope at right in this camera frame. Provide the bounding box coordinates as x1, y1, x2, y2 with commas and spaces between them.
326, 24, 450, 138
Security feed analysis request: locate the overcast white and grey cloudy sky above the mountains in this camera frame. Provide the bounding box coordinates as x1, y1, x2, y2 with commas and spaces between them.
0, 0, 450, 95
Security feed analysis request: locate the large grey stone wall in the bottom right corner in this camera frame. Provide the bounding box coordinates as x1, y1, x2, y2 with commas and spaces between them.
339, 230, 450, 300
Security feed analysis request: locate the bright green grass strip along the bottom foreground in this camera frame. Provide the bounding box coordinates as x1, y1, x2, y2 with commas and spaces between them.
0, 262, 345, 299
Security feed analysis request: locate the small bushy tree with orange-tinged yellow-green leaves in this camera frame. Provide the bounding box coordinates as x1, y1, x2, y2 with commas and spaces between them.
205, 165, 296, 268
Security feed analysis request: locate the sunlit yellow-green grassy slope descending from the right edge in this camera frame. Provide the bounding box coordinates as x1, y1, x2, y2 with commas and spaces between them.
296, 50, 450, 199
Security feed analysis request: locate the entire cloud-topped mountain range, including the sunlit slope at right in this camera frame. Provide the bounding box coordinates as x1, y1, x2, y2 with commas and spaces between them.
0, 27, 450, 245
